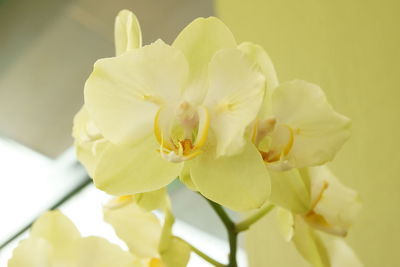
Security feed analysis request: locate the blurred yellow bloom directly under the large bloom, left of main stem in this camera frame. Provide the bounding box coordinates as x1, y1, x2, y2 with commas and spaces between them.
104, 193, 191, 267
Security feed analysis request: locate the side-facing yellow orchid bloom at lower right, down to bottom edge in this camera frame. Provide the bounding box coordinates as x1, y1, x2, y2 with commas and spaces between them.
271, 166, 362, 267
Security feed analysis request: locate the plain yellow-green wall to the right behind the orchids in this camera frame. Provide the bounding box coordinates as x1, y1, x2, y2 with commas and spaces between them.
216, 0, 400, 267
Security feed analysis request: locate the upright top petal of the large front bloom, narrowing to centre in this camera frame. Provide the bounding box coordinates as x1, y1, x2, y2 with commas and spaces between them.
172, 17, 236, 102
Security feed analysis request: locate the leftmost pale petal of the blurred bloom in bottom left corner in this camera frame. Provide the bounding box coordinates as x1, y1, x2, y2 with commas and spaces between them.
7, 238, 53, 267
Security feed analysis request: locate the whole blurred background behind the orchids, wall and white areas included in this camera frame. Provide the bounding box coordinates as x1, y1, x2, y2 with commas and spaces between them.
0, 0, 400, 267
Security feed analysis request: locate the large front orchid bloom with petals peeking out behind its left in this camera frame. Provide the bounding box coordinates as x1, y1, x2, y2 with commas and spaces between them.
74, 11, 270, 210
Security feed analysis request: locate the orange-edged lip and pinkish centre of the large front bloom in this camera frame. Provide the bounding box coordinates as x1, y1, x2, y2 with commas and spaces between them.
154, 102, 210, 163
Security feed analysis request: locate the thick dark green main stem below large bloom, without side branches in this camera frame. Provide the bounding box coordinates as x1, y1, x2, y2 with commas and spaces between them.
206, 198, 238, 267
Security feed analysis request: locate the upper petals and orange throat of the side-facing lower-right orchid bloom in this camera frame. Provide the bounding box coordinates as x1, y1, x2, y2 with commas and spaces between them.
271, 166, 361, 236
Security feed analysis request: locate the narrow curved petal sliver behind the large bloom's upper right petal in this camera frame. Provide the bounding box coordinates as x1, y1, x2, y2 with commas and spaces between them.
238, 42, 279, 118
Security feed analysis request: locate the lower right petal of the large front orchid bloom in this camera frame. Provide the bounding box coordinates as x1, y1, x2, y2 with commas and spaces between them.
190, 143, 270, 211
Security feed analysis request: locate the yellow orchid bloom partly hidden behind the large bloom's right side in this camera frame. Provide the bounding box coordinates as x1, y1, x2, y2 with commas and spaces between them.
240, 43, 350, 171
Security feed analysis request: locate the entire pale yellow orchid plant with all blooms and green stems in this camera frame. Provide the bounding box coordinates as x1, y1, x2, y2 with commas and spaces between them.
9, 10, 361, 267
